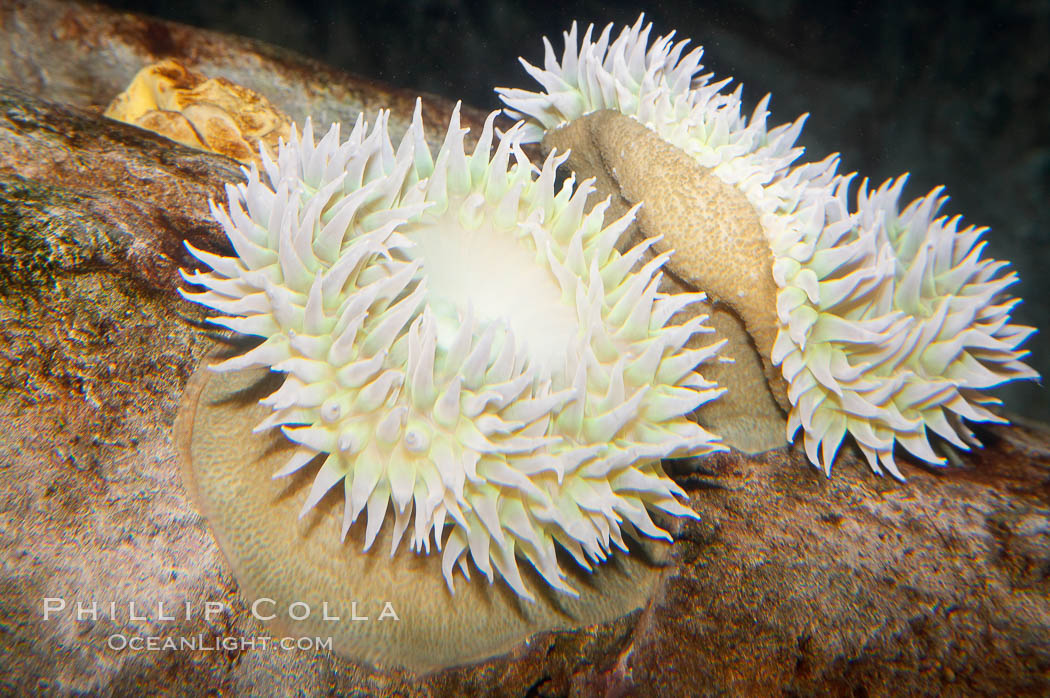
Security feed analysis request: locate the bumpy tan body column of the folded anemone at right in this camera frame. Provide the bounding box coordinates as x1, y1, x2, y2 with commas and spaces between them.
543, 109, 791, 453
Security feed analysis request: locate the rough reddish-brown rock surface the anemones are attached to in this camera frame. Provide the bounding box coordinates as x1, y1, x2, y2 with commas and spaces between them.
0, 2, 1050, 696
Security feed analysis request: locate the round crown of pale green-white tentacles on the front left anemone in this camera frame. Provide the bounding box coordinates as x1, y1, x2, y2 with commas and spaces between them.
184, 98, 722, 599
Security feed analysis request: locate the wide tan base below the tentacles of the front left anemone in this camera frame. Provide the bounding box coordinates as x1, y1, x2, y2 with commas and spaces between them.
175, 359, 670, 673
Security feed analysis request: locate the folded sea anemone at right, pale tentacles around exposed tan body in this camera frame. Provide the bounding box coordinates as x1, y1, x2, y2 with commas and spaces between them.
498, 17, 1037, 478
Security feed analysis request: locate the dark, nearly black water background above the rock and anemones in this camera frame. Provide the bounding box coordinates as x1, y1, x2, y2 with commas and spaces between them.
105, 0, 1050, 421
